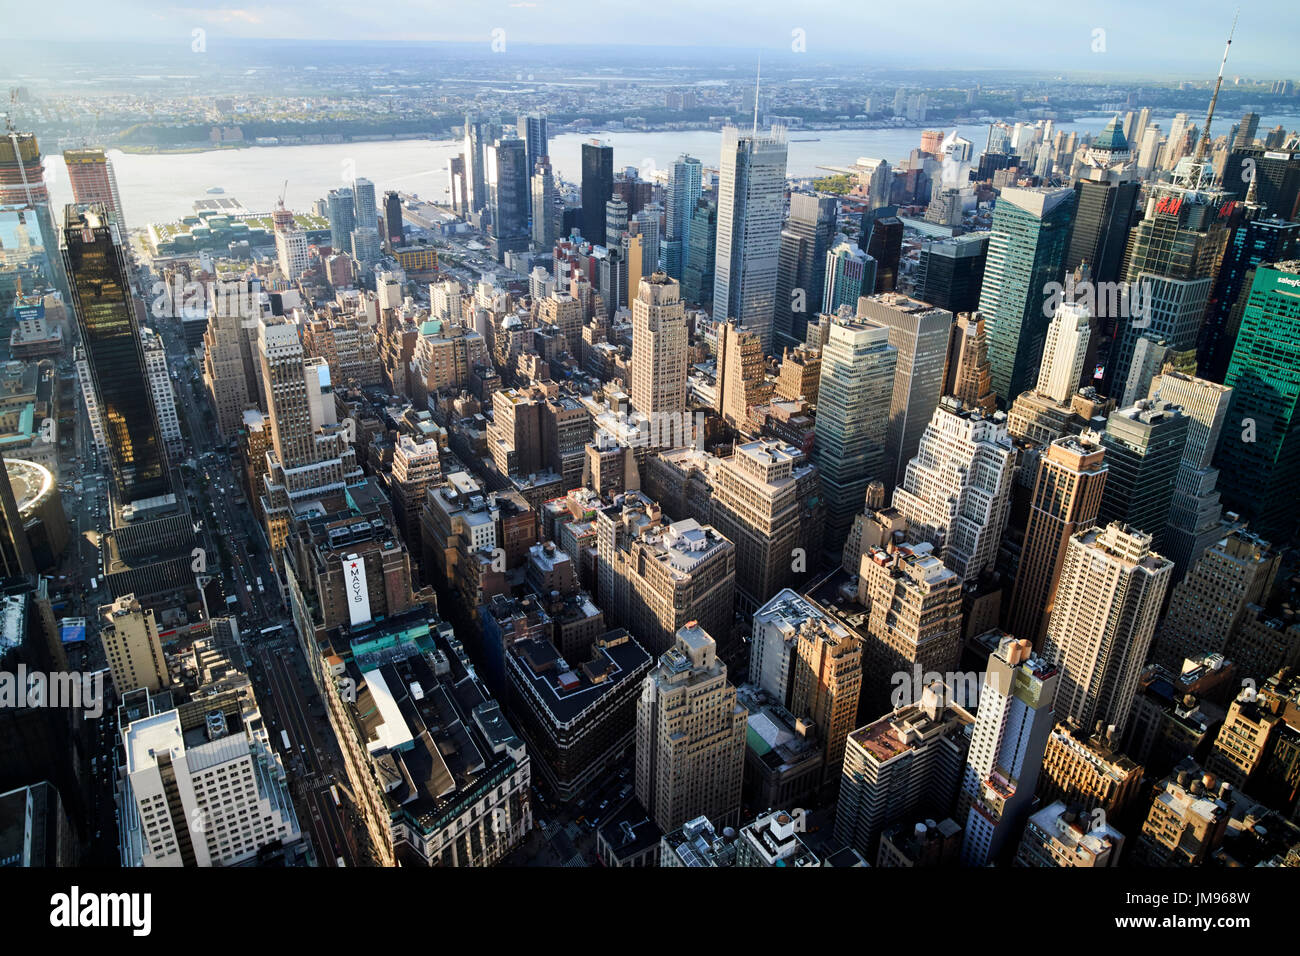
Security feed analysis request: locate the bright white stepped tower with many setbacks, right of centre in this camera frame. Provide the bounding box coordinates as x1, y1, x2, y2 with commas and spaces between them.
893, 398, 1015, 581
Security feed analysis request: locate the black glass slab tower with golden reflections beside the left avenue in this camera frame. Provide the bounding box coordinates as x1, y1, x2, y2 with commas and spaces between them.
64, 206, 172, 505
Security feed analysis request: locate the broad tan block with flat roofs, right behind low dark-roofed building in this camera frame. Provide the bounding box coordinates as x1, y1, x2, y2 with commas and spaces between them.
595, 492, 736, 654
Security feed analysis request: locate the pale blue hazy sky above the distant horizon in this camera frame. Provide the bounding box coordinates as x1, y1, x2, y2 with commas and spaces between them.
10, 0, 1300, 78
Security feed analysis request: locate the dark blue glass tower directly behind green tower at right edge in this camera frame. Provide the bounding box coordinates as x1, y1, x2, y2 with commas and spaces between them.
1196, 214, 1300, 381
